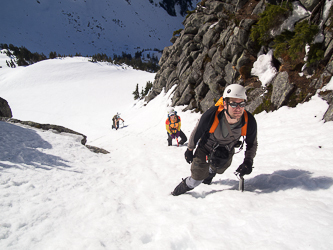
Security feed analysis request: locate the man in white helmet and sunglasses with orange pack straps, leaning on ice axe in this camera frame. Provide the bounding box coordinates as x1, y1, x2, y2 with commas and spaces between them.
172, 84, 257, 196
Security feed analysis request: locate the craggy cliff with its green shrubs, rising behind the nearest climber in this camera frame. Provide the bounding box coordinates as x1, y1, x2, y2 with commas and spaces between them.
145, 0, 333, 121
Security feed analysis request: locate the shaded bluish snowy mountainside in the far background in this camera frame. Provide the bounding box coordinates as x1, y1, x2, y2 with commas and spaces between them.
0, 0, 199, 56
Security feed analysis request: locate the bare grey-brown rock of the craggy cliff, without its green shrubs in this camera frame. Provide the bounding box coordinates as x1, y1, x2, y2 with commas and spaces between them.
145, 0, 333, 120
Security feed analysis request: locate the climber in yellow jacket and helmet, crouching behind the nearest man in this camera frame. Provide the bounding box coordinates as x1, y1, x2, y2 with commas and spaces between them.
165, 109, 187, 146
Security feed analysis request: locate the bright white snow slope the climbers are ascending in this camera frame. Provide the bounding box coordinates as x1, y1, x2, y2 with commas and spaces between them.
0, 49, 333, 250
